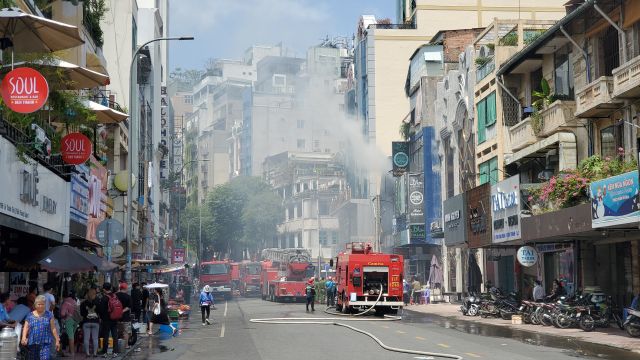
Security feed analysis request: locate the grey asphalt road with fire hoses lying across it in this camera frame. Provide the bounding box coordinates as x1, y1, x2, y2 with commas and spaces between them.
129, 299, 640, 360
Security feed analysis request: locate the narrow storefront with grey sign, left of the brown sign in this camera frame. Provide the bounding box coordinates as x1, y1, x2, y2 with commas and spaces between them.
442, 194, 468, 293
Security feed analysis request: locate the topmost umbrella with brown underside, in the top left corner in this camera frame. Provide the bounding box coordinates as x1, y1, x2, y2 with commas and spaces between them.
0, 8, 84, 53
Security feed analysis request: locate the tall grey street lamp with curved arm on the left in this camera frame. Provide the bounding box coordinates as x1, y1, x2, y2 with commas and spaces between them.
125, 36, 194, 282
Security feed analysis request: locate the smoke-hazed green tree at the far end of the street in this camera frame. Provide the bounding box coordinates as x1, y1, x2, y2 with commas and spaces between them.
202, 177, 283, 260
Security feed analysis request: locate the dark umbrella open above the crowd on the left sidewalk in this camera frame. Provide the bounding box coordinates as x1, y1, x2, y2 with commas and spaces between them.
38, 245, 118, 273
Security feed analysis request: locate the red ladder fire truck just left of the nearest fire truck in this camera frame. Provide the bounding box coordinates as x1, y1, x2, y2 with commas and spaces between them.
260, 248, 315, 302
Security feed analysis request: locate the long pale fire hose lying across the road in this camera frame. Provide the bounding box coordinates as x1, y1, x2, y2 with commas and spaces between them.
249, 289, 463, 360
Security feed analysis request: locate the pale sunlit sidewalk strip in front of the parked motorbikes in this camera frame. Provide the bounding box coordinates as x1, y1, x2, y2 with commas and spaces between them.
405, 303, 640, 354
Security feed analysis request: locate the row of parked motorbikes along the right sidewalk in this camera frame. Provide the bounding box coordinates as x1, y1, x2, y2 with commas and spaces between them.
460, 288, 640, 337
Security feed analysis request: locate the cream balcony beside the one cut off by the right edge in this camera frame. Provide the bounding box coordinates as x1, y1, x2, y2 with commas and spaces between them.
576, 76, 620, 118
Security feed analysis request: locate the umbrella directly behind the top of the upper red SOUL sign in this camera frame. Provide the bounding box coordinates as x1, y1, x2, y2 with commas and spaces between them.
3, 59, 109, 90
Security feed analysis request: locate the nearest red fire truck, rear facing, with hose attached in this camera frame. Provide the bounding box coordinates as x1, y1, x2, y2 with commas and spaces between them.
334, 242, 404, 315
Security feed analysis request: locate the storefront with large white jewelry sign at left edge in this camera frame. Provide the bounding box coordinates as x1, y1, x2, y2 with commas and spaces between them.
0, 136, 70, 296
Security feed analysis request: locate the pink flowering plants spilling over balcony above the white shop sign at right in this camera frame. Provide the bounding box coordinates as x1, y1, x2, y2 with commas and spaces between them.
528, 152, 638, 215
